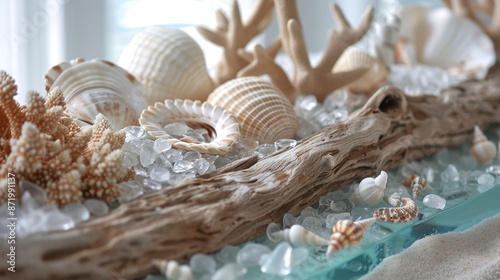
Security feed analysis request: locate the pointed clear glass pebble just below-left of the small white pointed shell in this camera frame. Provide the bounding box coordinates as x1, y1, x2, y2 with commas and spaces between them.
260, 242, 293, 276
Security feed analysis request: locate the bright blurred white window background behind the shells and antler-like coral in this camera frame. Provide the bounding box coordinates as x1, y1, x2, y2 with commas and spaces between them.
0, 0, 439, 103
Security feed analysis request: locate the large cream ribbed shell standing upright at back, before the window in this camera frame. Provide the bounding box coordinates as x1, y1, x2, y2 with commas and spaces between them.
118, 26, 215, 105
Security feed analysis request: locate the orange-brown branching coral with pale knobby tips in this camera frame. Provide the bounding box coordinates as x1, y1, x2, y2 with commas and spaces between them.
0, 71, 130, 206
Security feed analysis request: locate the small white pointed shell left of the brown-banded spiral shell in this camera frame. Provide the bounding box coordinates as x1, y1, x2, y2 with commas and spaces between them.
271, 225, 328, 246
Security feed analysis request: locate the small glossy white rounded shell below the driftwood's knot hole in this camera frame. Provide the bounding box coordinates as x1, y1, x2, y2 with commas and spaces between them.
351, 171, 387, 206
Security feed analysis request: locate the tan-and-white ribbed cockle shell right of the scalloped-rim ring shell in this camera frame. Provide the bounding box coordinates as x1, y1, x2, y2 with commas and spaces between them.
207, 77, 298, 143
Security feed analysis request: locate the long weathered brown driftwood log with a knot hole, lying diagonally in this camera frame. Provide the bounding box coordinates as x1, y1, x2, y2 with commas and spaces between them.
0, 80, 500, 279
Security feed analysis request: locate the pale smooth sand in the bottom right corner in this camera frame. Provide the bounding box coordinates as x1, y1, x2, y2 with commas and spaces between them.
362, 214, 500, 280
